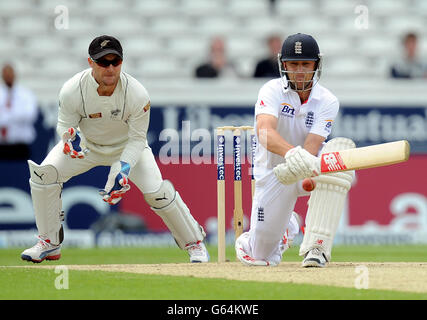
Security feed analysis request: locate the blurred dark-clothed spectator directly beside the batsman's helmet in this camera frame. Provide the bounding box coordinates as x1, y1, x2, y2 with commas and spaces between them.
254, 35, 282, 78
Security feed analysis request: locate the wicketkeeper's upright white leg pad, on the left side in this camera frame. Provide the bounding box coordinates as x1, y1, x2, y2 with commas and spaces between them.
28, 160, 64, 245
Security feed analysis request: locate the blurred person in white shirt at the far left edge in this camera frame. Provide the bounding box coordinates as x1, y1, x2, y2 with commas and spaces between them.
0, 64, 38, 160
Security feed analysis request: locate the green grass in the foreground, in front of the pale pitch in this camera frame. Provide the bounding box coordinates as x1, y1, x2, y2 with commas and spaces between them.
0, 269, 427, 300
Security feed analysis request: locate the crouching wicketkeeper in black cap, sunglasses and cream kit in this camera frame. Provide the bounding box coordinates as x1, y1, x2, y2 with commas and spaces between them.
21, 35, 209, 262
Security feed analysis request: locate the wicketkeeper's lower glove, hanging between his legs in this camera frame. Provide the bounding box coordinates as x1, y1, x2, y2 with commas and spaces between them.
99, 161, 130, 205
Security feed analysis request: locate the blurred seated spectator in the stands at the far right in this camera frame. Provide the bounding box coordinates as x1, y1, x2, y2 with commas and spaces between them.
390, 33, 427, 78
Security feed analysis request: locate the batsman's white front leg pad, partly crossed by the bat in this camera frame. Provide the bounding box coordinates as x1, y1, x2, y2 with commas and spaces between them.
299, 138, 355, 261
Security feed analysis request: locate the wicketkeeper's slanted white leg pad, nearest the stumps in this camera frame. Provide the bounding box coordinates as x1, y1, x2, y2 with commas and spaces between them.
144, 180, 206, 249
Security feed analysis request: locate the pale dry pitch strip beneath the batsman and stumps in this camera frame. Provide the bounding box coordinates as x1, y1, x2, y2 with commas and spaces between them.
27, 262, 427, 293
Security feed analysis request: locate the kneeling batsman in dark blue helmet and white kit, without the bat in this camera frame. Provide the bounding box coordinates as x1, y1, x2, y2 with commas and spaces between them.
235, 33, 355, 267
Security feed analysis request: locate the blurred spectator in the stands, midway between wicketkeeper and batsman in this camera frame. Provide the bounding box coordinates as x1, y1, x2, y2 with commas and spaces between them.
195, 37, 237, 78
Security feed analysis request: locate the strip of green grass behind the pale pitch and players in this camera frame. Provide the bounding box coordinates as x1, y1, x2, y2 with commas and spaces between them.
0, 245, 427, 266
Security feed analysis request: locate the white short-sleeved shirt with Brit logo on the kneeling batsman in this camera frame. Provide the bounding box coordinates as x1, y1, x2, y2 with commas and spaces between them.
254, 78, 339, 177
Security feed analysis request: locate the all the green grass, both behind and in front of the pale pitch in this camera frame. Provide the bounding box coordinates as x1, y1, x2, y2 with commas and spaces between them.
0, 246, 427, 300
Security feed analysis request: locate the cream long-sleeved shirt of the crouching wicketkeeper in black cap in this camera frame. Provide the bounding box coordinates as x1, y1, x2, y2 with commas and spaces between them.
57, 68, 150, 167
